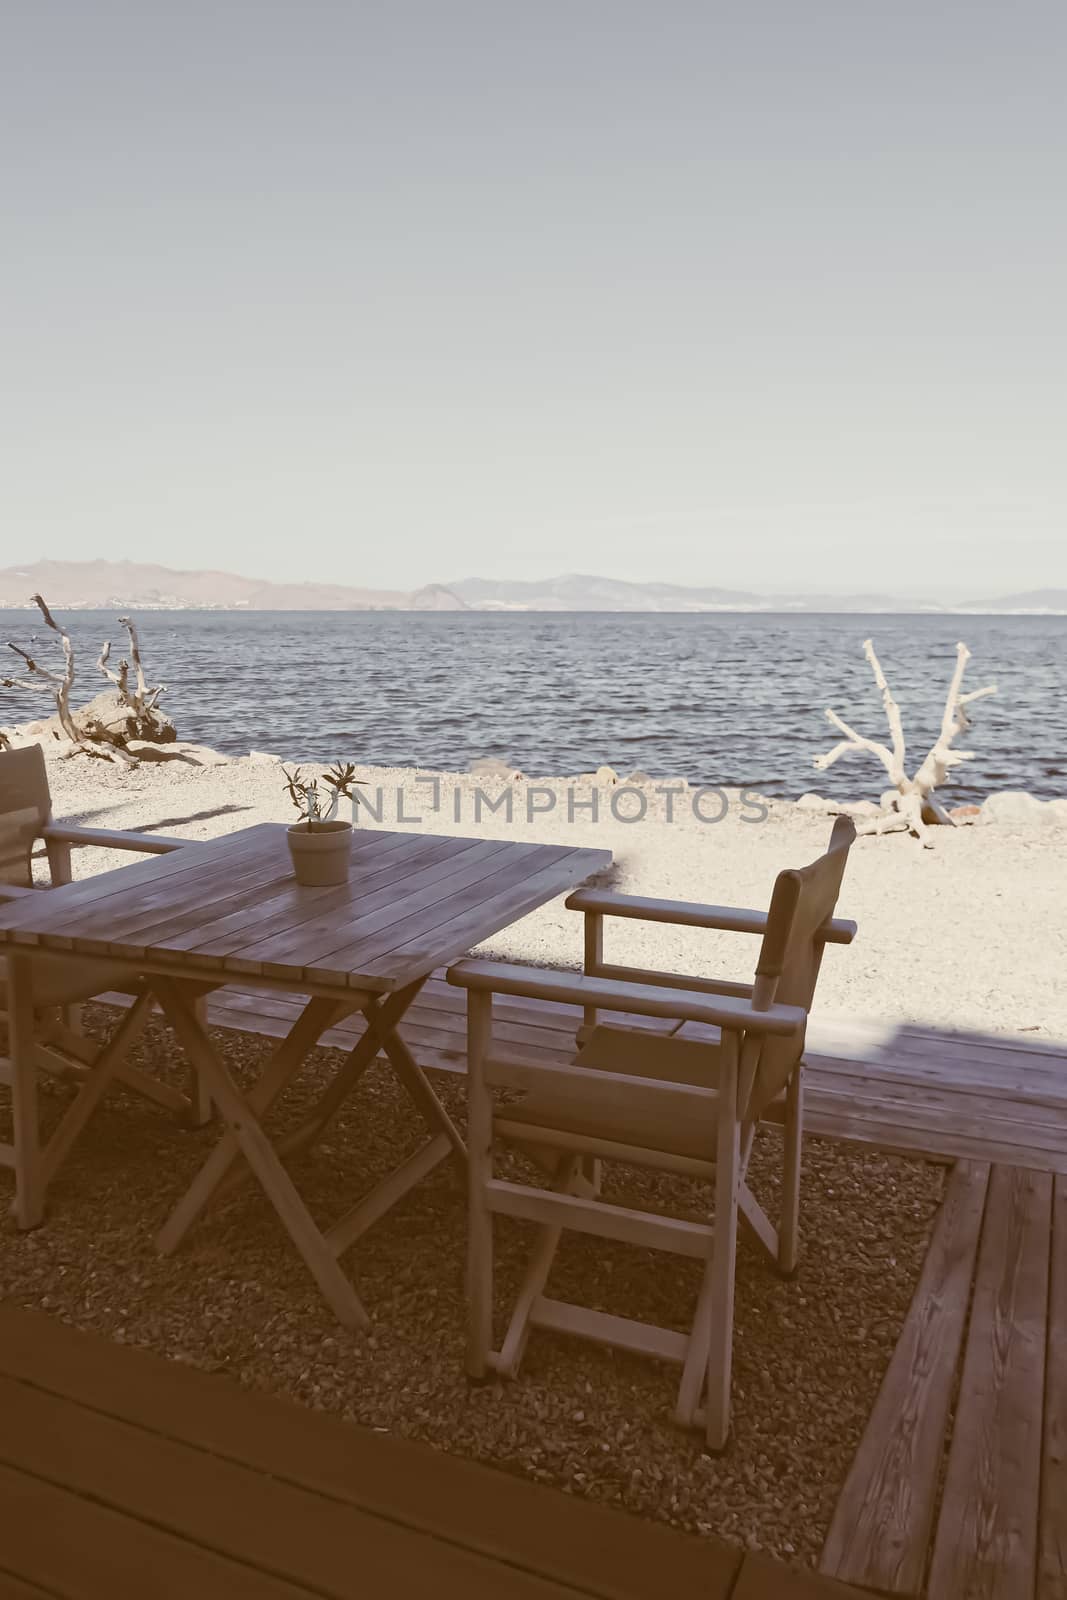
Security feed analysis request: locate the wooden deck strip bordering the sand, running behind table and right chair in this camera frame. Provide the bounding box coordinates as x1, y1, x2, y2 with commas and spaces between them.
107, 971, 1067, 1176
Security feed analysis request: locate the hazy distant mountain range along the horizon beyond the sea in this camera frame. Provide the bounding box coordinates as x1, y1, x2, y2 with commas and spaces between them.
0, 560, 1067, 614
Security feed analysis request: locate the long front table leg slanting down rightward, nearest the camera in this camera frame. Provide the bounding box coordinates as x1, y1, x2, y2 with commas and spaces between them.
155, 979, 370, 1328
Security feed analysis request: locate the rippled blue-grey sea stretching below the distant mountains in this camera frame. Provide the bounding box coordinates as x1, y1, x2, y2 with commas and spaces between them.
0, 611, 1067, 800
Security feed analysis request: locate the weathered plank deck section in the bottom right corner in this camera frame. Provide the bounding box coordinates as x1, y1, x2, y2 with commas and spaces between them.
821, 1162, 1067, 1600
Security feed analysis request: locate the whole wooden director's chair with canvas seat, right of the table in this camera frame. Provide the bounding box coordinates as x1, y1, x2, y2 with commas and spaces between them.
448, 818, 856, 1450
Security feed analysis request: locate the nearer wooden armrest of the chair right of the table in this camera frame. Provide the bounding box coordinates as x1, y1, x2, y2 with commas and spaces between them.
448, 962, 808, 1035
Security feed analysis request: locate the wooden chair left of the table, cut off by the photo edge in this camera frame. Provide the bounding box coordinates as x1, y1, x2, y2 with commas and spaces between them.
0, 746, 199, 1227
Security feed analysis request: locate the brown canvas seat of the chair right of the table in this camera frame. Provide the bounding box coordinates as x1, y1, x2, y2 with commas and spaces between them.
501, 1024, 718, 1165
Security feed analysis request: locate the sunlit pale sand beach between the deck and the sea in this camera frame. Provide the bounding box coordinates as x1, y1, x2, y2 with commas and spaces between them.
41, 760, 1067, 1040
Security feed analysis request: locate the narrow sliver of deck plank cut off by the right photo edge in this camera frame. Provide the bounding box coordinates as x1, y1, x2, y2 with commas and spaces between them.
1037, 1178, 1067, 1600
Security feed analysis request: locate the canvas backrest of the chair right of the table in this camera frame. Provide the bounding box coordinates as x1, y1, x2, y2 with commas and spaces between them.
749, 816, 856, 1117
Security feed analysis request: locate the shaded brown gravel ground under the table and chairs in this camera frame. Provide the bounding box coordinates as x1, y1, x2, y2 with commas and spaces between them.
0, 1006, 944, 1563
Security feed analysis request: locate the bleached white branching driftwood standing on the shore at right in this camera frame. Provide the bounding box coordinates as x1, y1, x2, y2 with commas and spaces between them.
814, 638, 997, 845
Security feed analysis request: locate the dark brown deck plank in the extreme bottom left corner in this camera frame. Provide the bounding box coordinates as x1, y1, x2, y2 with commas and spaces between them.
0, 1466, 314, 1600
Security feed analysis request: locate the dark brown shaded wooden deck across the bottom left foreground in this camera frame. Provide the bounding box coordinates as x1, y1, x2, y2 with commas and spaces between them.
0, 1306, 849, 1600
